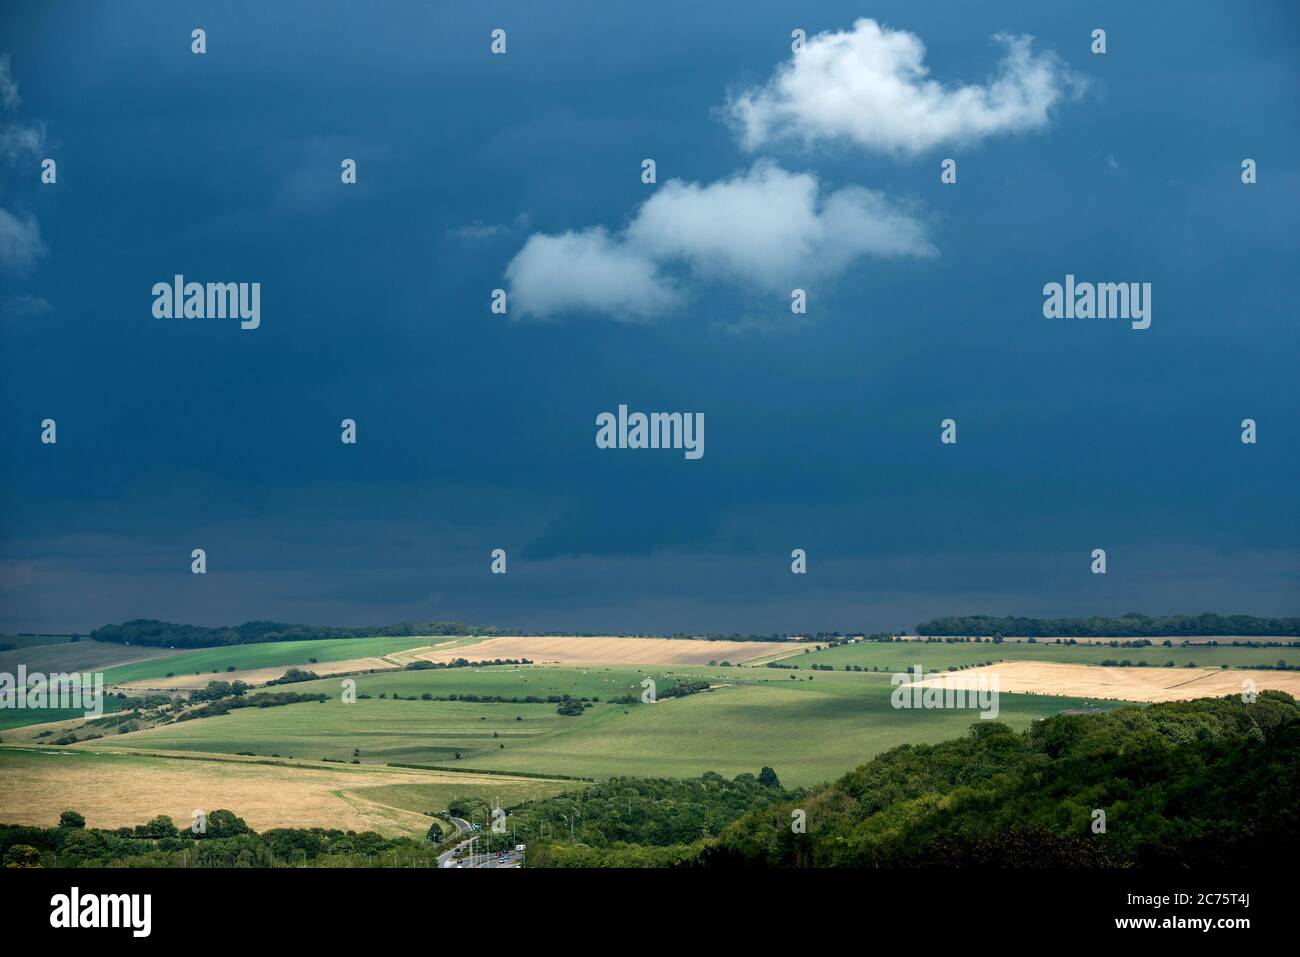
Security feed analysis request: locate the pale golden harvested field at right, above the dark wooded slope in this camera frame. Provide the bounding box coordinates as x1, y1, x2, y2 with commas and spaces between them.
922, 662, 1300, 702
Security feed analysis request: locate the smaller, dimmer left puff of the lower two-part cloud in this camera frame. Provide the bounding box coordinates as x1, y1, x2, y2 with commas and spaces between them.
506, 226, 677, 320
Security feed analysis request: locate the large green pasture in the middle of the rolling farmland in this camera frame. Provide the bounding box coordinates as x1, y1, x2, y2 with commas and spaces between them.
95, 667, 1123, 784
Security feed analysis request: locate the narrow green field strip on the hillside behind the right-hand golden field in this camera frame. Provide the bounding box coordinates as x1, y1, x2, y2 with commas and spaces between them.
781, 641, 1300, 674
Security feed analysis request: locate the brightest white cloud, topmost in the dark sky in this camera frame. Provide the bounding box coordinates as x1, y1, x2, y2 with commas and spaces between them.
727, 20, 1083, 153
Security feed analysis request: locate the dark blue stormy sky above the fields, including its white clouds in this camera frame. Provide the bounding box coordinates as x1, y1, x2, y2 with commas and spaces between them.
0, 3, 1300, 632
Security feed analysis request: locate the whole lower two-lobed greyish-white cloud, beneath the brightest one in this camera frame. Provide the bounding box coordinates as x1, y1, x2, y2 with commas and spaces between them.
506, 160, 937, 320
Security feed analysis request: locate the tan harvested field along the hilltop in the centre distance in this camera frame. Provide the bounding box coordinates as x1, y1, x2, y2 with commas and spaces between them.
416, 636, 776, 664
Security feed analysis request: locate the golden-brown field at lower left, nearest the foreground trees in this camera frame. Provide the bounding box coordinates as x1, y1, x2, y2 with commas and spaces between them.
0, 749, 572, 836
